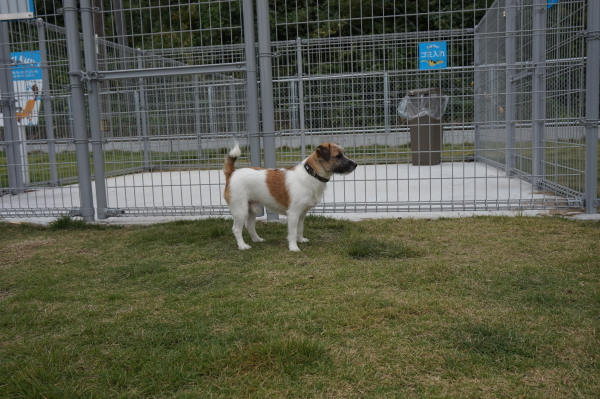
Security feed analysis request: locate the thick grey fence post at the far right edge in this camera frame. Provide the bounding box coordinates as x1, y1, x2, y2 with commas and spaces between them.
585, 1, 600, 213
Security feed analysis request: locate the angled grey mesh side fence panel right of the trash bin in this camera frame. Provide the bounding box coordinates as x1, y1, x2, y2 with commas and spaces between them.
475, 0, 585, 200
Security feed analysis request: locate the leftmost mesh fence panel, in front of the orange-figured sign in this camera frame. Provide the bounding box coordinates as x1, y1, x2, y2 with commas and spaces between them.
0, 20, 84, 216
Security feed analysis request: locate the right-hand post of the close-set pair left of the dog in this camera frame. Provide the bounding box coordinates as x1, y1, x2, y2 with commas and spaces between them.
80, 0, 108, 219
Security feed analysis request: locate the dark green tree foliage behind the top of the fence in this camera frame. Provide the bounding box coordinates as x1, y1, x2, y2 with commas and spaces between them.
35, 0, 492, 49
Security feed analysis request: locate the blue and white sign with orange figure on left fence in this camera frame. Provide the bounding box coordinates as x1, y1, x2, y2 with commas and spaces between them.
0, 51, 42, 126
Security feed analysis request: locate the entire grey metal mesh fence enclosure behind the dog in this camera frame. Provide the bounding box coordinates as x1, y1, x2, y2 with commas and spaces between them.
0, 0, 599, 220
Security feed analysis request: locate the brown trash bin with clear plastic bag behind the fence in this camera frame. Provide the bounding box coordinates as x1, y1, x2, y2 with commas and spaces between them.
407, 88, 444, 166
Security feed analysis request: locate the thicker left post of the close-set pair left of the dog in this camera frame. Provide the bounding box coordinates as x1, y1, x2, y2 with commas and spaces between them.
63, 0, 94, 222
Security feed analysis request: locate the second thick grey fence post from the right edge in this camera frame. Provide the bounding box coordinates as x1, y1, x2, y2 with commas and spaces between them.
531, 0, 548, 188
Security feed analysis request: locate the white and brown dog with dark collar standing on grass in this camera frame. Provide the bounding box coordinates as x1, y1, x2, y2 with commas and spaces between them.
223, 143, 356, 251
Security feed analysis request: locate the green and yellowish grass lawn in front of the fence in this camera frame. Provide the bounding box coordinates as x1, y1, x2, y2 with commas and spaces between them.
0, 216, 600, 399
